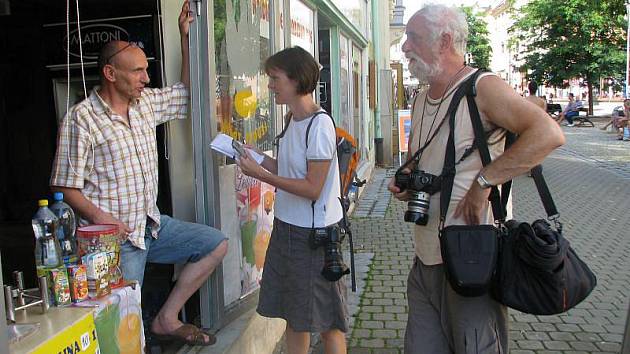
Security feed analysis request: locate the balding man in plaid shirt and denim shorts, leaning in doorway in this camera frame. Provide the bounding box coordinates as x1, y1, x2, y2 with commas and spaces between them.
50, 0, 227, 345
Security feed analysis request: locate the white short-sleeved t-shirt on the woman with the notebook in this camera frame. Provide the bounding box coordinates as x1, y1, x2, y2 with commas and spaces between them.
274, 113, 343, 227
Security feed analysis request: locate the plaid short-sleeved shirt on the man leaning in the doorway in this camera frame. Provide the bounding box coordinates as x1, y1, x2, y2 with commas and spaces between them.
50, 83, 188, 249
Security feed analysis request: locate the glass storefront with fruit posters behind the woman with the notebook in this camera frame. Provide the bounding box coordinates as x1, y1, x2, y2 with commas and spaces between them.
162, 0, 388, 334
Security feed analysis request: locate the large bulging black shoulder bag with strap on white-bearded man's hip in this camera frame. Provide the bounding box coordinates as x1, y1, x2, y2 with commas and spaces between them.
440, 71, 597, 315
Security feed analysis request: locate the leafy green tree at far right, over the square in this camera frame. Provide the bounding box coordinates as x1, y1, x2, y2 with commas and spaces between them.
514, 0, 626, 114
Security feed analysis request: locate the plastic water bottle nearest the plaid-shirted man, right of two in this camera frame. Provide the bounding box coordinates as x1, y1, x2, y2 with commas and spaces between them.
50, 192, 79, 266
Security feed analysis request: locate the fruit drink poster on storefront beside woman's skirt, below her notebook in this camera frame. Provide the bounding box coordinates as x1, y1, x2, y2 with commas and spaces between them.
235, 169, 275, 296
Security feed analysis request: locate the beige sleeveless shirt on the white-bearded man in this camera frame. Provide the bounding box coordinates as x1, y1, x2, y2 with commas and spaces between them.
409, 71, 512, 265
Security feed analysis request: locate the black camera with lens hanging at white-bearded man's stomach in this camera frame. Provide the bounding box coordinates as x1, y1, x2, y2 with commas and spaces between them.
394, 168, 441, 225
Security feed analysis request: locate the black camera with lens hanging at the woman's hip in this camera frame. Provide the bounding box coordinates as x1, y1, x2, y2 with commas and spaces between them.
308, 225, 350, 281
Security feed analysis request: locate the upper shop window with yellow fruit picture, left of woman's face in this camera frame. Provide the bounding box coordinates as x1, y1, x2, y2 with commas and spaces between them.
214, 0, 275, 151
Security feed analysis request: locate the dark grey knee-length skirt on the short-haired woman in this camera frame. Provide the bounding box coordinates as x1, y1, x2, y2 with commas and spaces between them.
256, 219, 348, 333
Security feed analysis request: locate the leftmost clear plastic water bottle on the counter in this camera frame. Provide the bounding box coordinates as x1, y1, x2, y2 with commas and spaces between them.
32, 199, 63, 276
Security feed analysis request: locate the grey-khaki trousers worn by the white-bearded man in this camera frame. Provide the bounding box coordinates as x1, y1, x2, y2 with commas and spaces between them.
405, 257, 509, 354
